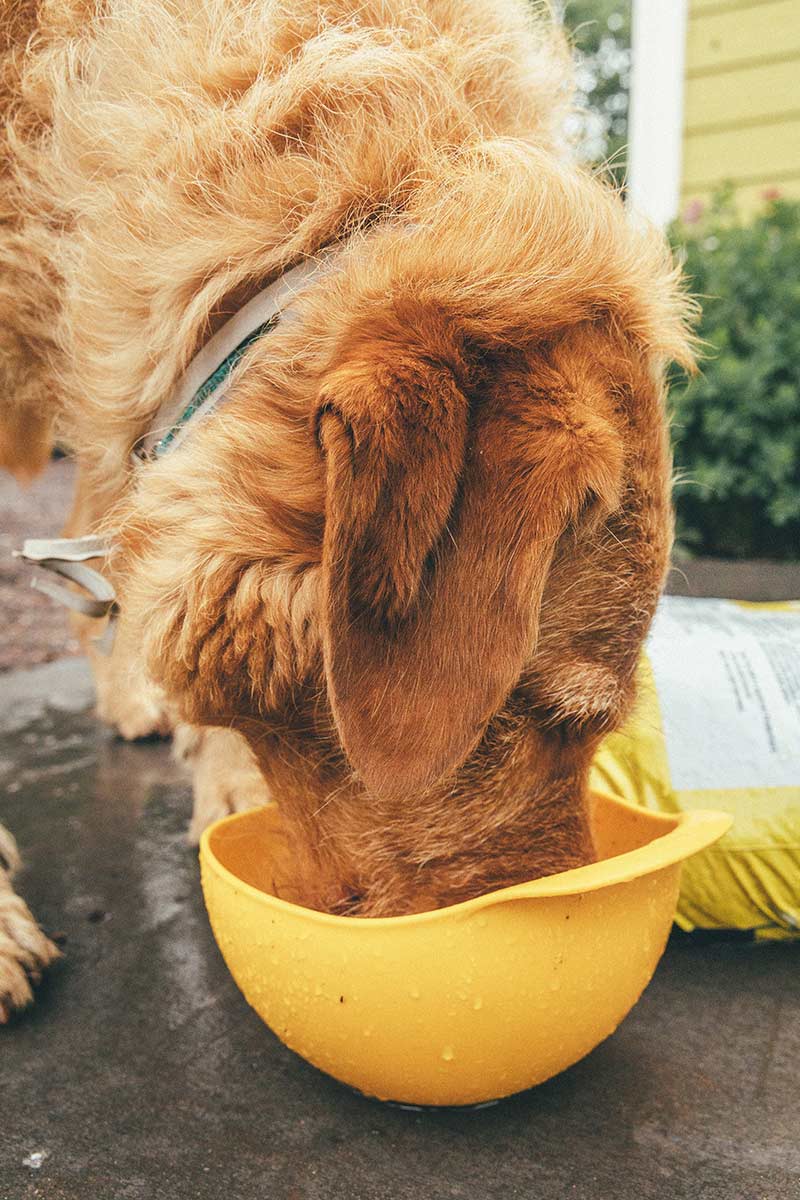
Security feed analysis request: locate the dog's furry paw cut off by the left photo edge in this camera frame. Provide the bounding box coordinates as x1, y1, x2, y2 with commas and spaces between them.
0, 826, 60, 1025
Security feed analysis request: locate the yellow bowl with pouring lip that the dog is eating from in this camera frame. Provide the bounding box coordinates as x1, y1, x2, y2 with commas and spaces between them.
200, 794, 730, 1104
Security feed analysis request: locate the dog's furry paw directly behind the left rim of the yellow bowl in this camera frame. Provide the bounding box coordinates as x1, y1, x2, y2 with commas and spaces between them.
174, 725, 270, 845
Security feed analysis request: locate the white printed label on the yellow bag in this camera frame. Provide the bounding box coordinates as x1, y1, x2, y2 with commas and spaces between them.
646, 596, 800, 792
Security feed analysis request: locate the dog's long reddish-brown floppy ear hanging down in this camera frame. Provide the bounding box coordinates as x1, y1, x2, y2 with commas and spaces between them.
318, 343, 621, 797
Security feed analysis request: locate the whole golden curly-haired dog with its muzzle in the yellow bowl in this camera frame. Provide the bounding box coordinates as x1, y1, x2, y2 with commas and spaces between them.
0, 0, 691, 1009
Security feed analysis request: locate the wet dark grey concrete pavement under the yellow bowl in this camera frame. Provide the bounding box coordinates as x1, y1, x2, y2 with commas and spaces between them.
0, 660, 800, 1200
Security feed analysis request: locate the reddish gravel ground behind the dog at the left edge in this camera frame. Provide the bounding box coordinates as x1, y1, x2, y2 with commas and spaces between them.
0, 458, 80, 671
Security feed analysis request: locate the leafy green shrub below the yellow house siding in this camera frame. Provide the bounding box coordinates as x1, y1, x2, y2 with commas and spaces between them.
670, 194, 800, 558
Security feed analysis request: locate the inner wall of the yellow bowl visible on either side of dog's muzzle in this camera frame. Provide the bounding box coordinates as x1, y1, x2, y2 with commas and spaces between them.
207, 794, 679, 919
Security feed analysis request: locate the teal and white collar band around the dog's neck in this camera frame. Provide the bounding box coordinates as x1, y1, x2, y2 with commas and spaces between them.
134, 246, 341, 461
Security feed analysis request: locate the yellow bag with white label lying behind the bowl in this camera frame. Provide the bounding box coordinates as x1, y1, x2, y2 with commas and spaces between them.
591, 596, 800, 937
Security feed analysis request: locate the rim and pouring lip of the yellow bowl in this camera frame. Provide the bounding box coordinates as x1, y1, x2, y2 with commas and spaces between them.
199, 788, 733, 930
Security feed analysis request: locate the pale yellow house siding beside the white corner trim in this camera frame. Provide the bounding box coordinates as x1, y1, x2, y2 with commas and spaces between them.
681, 0, 800, 210
